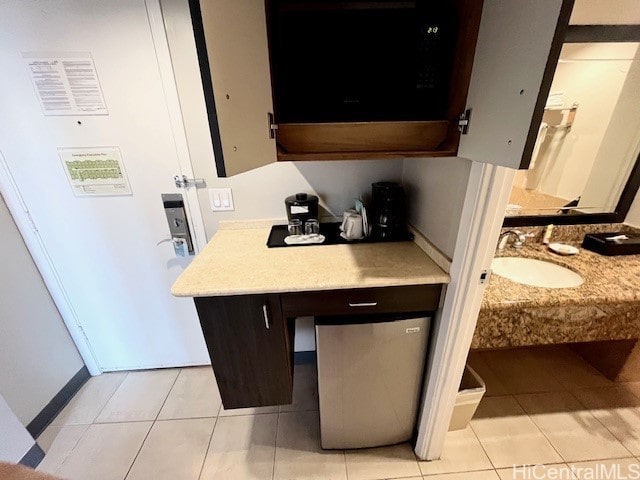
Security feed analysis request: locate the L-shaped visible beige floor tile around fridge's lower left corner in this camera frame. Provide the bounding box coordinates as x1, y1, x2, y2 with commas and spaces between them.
274, 411, 347, 480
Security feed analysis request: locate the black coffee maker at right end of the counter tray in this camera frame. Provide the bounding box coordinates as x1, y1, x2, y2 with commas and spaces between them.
371, 182, 407, 240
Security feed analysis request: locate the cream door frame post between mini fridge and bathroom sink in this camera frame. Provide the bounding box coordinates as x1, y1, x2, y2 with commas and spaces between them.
415, 162, 516, 460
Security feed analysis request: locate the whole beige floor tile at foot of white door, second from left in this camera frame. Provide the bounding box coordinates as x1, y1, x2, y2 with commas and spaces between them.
96, 369, 180, 423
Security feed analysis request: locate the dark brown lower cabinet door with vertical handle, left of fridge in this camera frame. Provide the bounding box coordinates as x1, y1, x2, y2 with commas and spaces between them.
195, 295, 293, 409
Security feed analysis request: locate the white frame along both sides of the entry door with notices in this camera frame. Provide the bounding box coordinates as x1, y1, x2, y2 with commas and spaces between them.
0, 0, 207, 376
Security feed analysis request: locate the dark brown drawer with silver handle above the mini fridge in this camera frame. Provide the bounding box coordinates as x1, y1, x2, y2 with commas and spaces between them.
281, 284, 442, 317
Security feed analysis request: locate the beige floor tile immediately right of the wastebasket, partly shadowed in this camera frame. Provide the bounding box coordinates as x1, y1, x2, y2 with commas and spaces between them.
471, 396, 562, 468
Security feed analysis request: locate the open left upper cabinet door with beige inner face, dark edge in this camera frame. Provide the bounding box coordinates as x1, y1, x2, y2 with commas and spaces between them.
189, 0, 276, 177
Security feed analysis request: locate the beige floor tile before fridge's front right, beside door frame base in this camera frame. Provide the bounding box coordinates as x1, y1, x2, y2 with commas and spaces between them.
345, 443, 420, 480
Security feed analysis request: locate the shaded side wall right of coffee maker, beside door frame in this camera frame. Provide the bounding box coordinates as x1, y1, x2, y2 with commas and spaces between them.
402, 157, 471, 258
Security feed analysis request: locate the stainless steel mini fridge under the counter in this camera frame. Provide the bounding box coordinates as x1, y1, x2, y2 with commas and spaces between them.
316, 315, 430, 449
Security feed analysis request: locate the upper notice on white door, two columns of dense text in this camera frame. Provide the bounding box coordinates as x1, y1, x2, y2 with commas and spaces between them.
22, 53, 109, 115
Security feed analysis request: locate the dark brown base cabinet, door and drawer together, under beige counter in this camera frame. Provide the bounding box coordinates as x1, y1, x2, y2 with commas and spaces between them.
194, 284, 442, 409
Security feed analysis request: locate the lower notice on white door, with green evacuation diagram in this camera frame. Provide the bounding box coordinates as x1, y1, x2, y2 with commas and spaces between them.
58, 147, 131, 197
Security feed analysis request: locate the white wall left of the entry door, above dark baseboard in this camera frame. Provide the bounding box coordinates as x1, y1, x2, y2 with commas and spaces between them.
0, 195, 84, 424
